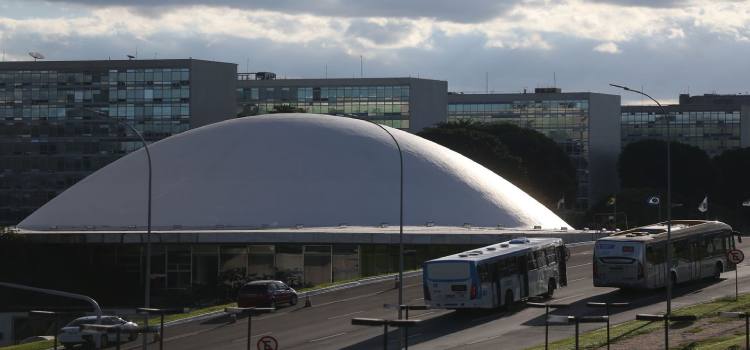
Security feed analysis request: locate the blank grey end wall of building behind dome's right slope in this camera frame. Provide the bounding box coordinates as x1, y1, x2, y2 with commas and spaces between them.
589, 94, 622, 207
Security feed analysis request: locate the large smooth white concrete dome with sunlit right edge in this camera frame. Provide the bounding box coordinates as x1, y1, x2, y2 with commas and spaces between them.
18, 114, 569, 230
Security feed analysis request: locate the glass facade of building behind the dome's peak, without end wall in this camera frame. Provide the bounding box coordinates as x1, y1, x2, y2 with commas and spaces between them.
237, 85, 409, 130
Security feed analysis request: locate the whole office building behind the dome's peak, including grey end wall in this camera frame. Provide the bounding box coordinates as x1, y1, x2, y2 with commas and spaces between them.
237, 72, 448, 133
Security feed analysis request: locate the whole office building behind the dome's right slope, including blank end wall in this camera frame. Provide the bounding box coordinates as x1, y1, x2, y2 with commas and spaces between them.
448, 88, 621, 212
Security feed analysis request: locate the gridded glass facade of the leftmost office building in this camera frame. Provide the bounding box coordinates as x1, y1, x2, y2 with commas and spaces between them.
0, 68, 190, 225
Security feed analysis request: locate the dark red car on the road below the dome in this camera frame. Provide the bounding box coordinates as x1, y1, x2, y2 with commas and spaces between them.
237, 281, 299, 308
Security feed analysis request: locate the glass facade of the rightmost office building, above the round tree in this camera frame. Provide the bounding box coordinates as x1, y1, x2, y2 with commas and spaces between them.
621, 107, 741, 157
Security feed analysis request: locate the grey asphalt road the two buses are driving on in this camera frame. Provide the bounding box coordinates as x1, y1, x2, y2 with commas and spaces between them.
116, 239, 750, 350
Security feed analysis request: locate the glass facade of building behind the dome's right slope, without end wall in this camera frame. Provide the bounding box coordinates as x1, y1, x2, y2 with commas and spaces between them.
448, 100, 589, 210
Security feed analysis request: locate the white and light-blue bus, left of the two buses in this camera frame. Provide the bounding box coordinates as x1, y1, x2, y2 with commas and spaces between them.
422, 237, 569, 309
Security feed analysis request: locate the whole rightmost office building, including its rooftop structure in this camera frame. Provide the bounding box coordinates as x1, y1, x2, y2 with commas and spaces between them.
621, 94, 750, 157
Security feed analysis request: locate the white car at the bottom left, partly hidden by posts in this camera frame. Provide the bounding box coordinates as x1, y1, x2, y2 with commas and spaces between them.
57, 316, 138, 349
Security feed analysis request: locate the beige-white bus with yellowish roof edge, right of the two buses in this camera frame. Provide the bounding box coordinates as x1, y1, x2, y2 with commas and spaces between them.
593, 220, 735, 289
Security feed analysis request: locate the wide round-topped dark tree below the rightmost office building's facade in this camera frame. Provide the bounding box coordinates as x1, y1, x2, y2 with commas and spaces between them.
617, 140, 716, 200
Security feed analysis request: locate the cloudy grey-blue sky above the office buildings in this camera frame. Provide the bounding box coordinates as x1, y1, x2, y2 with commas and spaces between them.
0, 0, 750, 104
